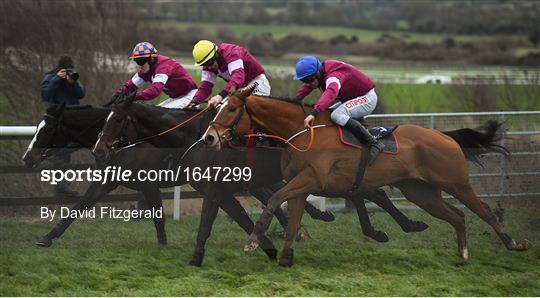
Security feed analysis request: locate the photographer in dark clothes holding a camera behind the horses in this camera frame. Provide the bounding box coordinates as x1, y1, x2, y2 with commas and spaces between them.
41, 55, 86, 196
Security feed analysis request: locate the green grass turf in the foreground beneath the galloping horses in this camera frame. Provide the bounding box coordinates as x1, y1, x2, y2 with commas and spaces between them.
0, 207, 540, 296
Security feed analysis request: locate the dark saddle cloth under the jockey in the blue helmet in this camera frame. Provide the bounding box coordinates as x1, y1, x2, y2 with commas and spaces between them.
338, 126, 399, 154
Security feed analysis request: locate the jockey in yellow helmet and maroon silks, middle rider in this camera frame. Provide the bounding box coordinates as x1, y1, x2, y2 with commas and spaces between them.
188, 40, 270, 106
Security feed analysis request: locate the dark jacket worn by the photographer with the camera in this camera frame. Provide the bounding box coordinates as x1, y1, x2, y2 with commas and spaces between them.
41, 70, 86, 106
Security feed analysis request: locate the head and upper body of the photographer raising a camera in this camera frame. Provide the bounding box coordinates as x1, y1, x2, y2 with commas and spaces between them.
41, 56, 86, 106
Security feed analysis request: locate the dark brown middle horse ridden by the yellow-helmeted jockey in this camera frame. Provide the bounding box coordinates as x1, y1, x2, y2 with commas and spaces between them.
94, 94, 427, 264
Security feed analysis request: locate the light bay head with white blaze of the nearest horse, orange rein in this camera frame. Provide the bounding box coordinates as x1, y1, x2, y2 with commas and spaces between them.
203, 85, 256, 150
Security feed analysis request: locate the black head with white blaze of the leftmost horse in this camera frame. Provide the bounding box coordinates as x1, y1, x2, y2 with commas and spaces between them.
22, 103, 69, 167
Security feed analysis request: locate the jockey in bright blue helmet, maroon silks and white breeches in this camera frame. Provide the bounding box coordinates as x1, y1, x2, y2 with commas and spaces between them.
294, 56, 384, 163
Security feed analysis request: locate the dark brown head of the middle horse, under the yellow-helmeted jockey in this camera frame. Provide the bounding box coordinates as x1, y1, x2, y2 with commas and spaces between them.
92, 92, 136, 162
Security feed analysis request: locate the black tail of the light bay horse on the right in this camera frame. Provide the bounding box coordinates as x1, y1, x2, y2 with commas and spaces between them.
442, 120, 510, 165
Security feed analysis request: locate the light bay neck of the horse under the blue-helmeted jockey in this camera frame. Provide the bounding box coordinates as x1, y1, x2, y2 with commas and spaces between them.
248, 96, 312, 138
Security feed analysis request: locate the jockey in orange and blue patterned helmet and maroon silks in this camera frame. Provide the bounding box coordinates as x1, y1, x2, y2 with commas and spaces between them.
120, 42, 197, 108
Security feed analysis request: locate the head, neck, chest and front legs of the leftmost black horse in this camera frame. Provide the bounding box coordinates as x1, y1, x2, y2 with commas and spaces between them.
22, 104, 171, 247
